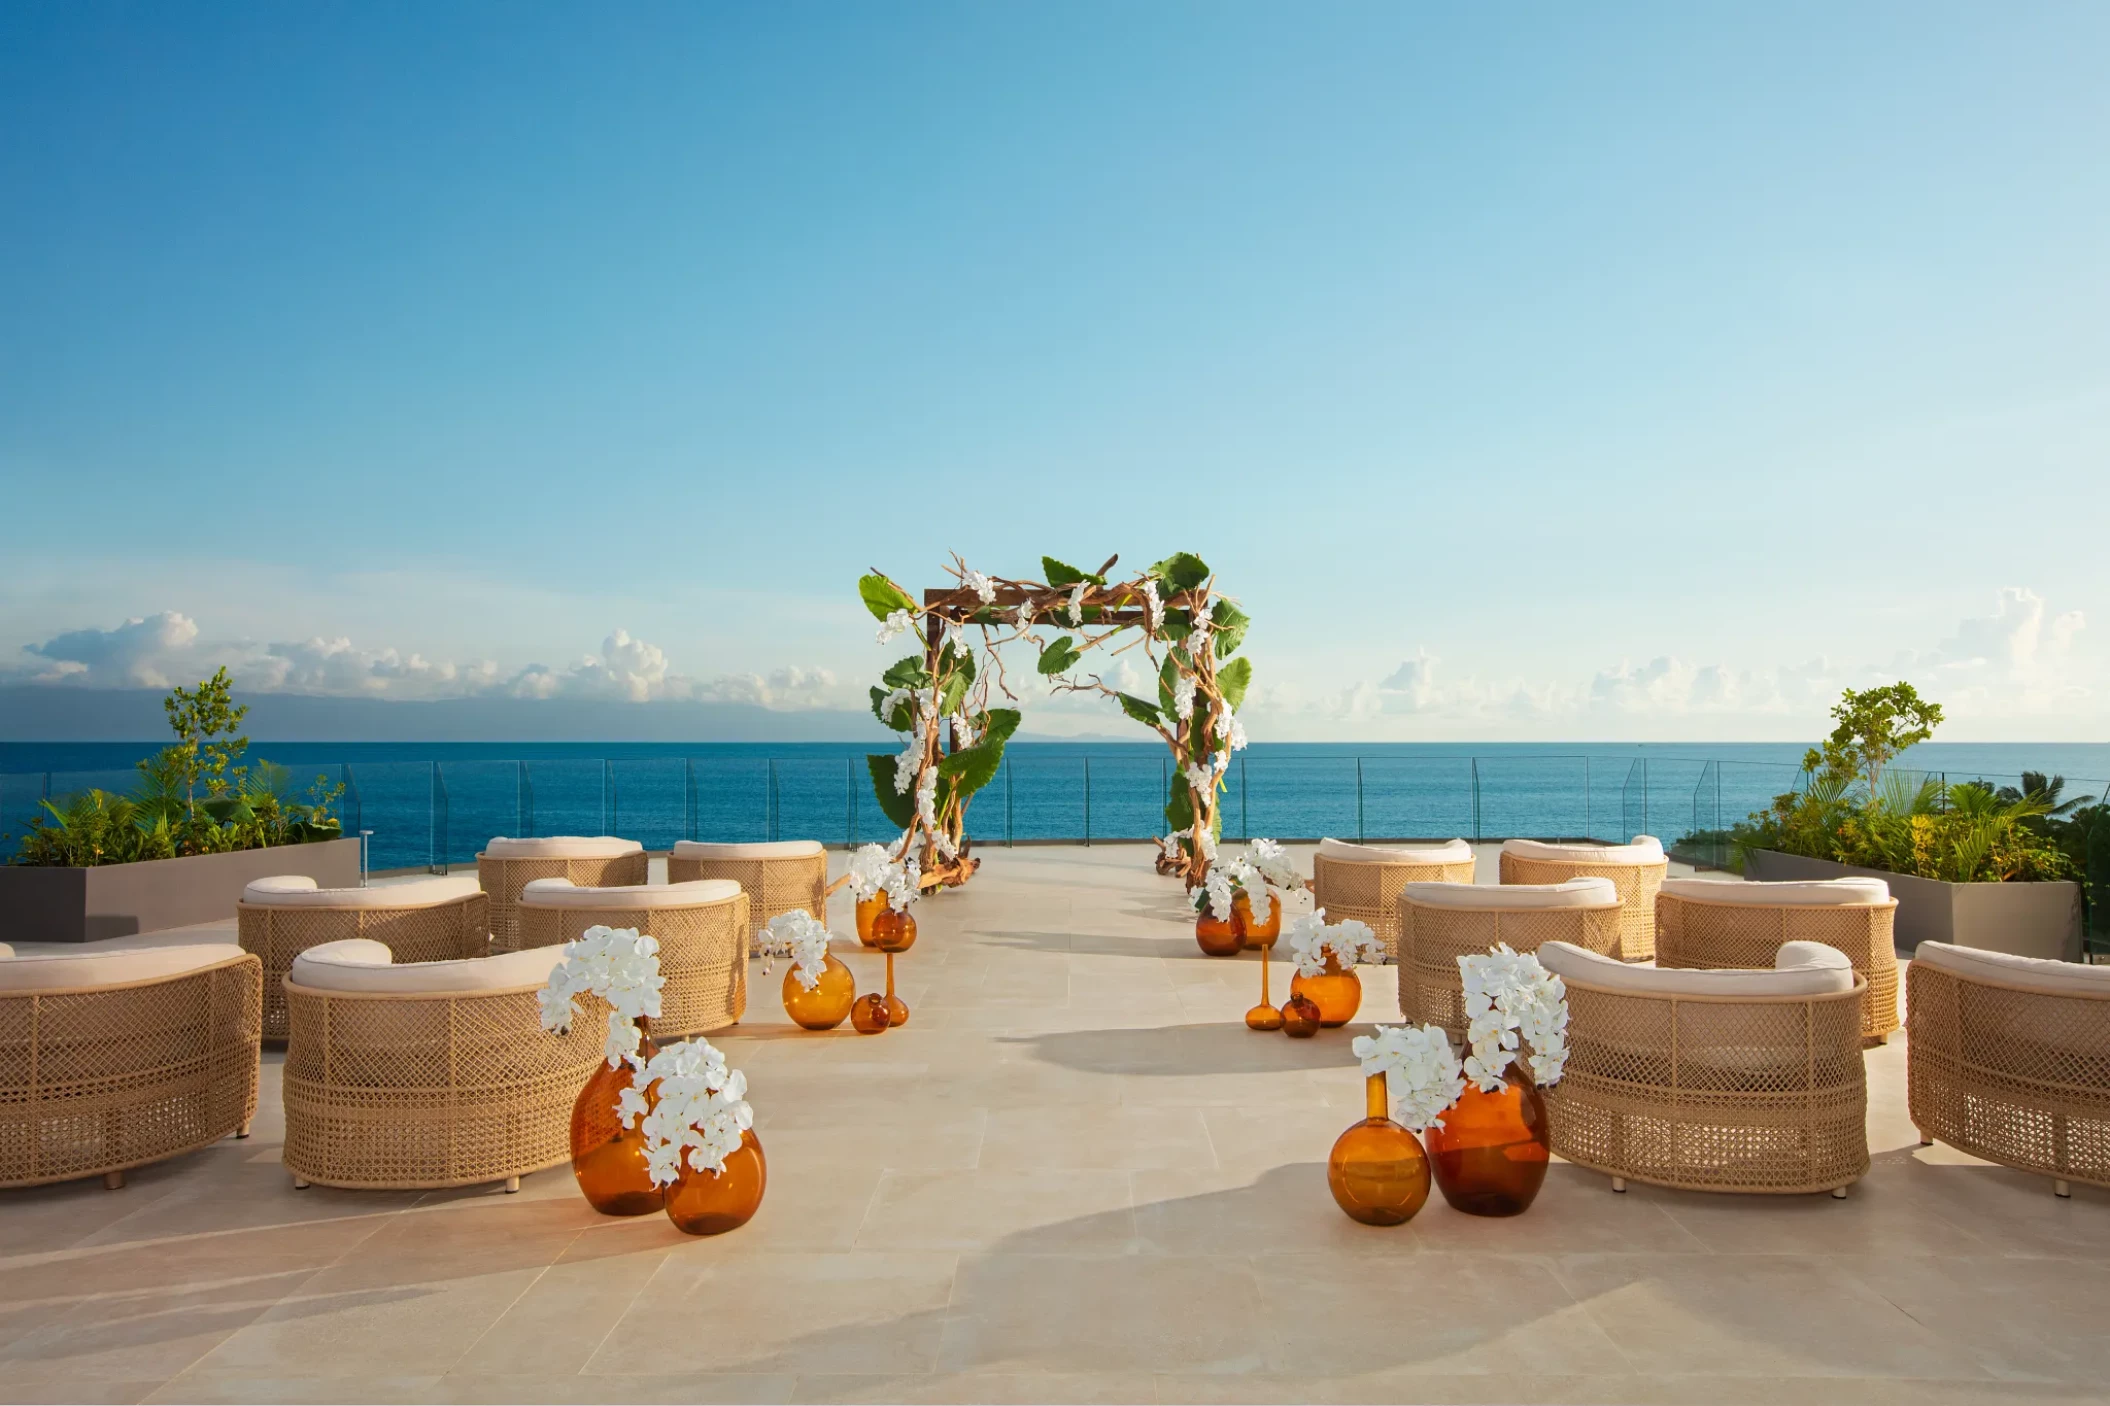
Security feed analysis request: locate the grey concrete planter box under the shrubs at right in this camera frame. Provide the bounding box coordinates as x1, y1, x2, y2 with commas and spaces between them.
1743, 849, 2080, 963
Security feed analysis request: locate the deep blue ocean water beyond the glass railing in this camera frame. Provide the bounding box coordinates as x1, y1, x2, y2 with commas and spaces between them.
0, 743, 2110, 870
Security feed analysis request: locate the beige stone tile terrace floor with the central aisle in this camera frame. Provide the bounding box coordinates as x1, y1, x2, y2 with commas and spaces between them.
0, 847, 2110, 1404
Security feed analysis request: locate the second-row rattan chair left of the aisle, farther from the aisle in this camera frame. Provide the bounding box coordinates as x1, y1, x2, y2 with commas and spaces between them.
234, 874, 492, 1041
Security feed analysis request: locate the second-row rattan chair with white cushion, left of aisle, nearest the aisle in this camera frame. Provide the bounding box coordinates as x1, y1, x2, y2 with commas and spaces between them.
521, 878, 753, 1037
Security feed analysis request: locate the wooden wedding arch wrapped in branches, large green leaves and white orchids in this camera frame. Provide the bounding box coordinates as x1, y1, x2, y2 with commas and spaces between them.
857, 551, 1253, 889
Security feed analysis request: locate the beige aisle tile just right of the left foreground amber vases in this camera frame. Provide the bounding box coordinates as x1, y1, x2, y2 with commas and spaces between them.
857, 1170, 1135, 1254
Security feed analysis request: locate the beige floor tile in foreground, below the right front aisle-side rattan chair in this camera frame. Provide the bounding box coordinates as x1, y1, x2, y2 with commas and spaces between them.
1555, 1254, 1986, 1381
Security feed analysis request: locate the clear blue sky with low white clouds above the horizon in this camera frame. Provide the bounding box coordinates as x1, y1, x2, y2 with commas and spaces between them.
0, 4, 2110, 739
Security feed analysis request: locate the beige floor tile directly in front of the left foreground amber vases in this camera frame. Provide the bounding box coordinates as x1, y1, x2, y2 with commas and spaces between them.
587, 1241, 958, 1374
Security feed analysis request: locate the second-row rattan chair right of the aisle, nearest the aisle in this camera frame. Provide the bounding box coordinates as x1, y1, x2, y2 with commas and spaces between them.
1393, 878, 1620, 1039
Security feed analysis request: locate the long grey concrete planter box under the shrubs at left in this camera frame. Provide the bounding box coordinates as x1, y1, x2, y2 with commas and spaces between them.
0, 836, 359, 942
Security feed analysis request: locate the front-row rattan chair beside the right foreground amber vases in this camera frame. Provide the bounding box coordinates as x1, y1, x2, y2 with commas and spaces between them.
1538, 928, 1867, 1197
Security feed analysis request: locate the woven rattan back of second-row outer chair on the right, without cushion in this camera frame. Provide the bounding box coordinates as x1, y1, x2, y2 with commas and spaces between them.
1656, 893, 1897, 1045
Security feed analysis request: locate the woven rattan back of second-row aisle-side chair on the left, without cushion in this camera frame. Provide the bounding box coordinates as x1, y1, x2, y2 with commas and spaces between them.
519, 893, 751, 1043
